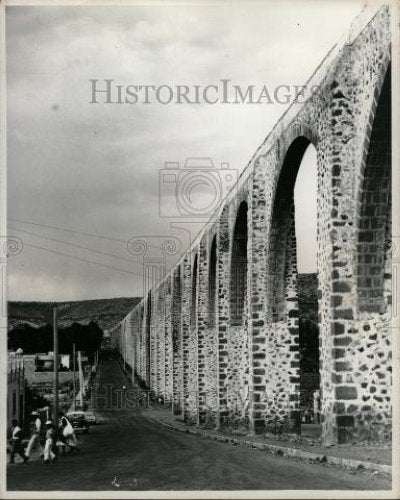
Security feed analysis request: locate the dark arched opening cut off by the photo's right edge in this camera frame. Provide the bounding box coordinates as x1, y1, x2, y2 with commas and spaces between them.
357, 62, 392, 316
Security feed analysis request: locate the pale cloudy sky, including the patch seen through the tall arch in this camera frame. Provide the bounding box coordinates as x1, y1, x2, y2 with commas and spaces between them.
6, 0, 363, 301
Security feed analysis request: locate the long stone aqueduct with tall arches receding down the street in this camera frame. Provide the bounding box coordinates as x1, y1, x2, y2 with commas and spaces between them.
111, 7, 392, 443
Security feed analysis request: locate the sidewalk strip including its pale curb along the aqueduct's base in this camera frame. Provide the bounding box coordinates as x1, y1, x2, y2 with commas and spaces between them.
143, 408, 392, 474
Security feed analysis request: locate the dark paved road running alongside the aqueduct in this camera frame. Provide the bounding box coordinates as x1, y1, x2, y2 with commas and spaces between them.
7, 354, 390, 491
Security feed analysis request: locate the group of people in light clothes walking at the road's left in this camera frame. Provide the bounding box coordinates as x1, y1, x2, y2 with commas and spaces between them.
10, 411, 79, 464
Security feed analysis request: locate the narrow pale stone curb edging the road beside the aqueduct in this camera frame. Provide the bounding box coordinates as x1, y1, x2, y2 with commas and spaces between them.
143, 415, 392, 475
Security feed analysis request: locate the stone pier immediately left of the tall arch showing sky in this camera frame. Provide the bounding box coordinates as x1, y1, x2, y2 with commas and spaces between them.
251, 146, 299, 438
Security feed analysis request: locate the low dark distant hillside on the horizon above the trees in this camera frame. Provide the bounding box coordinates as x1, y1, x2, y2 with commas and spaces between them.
8, 297, 141, 330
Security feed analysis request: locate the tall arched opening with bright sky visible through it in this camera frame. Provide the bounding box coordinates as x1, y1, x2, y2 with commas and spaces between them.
268, 136, 320, 434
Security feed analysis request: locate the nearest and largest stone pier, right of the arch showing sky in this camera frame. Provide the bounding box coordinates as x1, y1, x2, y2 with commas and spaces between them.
322, 10, 391, 441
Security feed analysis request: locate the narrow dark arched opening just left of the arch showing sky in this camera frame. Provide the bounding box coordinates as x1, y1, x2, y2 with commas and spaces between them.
230, 201, 247, 326
